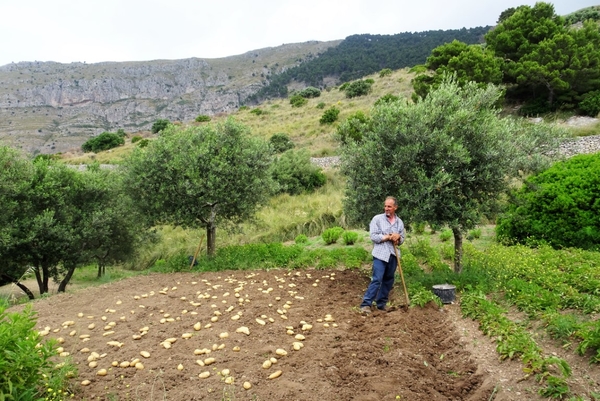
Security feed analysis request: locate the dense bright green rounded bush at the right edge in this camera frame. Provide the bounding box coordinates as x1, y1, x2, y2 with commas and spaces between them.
496, 154, 600, 249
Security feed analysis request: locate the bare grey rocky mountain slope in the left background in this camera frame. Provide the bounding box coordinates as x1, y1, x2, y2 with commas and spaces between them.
0, 41, 340, 154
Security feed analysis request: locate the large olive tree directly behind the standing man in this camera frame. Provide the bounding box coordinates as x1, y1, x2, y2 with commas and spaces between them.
341, 78, 558, 272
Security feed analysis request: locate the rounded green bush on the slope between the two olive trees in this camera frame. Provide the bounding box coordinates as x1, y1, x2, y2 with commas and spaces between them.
270, 149, 327, 195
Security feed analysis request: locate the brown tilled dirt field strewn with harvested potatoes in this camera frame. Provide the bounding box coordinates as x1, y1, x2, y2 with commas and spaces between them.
5, 269, 600, 401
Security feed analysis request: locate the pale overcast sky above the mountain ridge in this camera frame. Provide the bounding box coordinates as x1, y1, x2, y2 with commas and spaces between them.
0, 0, 600, 65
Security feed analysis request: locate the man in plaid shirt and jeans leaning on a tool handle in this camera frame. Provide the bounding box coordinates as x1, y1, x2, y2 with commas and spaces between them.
360, 196, 406, 314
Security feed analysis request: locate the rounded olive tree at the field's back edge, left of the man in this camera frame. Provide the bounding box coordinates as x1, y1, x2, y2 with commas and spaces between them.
125, 119, 272, 256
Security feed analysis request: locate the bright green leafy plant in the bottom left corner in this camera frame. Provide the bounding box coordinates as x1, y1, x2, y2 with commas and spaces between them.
0, 305, 76, 401
